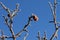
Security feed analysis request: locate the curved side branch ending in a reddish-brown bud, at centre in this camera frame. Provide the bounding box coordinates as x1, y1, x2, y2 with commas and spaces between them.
16, 15, 38, 37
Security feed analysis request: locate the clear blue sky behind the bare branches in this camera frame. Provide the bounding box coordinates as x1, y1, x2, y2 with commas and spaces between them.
0, 0, 60, 40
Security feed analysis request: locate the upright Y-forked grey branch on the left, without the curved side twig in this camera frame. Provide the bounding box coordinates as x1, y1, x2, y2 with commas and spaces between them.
0, 2, 19, 40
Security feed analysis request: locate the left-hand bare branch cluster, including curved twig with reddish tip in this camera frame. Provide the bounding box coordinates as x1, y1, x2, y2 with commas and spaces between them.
0, 2, 38, 40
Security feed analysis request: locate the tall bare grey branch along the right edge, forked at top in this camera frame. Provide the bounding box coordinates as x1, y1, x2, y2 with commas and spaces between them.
49, 0, 59, 40
